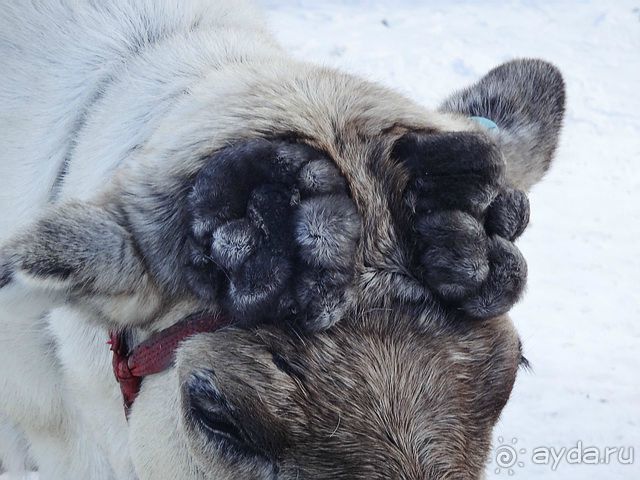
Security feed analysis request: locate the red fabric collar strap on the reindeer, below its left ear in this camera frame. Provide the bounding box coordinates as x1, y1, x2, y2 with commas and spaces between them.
107, 316, 227, 416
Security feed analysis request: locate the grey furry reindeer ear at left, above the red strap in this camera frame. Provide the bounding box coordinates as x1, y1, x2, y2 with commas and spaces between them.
0, 203, 158, 323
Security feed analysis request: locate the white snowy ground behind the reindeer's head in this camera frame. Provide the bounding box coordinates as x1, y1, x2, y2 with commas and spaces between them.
262, 0, 640, 480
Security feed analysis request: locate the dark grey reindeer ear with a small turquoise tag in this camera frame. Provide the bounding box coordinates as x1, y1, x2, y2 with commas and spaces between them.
440, 59, 565, 190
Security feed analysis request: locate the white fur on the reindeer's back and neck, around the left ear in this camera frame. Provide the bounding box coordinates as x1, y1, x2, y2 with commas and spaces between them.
0, 0, 278, 480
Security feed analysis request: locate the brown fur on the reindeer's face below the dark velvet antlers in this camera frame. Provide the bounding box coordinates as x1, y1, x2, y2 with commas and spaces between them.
178, 308, 520, 480
